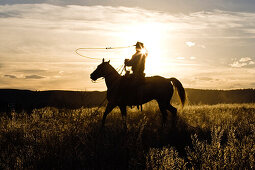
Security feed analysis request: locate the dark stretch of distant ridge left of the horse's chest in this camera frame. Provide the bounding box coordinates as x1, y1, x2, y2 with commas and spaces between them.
0, 89, 106, 112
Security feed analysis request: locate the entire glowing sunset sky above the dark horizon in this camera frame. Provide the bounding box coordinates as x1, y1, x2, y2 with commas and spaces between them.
0, 0, 255, 91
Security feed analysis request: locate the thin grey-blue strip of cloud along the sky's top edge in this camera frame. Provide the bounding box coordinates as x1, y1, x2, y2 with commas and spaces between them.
0, 0, 255, 13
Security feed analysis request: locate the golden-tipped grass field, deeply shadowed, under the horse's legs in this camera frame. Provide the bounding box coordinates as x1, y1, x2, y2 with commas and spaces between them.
0, 102, 255, 169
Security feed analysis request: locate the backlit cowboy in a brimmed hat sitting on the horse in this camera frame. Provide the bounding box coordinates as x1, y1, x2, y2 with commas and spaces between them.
124, 42, 148, 78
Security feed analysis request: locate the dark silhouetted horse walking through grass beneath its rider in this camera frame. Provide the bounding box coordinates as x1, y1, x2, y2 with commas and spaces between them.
90, 59, 186, 128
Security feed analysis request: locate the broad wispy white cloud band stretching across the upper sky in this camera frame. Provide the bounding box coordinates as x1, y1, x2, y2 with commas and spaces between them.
0, 4, 255, 38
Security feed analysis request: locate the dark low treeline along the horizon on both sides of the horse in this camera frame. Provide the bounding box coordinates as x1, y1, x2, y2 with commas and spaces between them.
0, 89, 255, 112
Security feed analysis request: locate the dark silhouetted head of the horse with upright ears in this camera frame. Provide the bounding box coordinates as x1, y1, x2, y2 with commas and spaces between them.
90, 59, 110, 81
